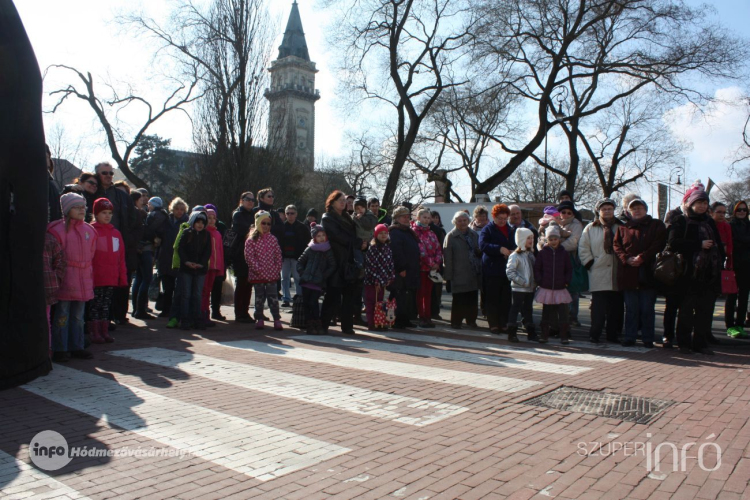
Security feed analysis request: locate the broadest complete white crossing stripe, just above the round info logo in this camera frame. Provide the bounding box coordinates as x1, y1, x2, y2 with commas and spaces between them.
22, 365, 351, 481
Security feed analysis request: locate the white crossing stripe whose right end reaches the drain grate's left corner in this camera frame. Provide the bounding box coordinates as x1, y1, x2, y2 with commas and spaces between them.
216, 337, 541, 392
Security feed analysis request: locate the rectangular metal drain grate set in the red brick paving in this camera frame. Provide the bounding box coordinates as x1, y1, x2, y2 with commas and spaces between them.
524, 387, 675, 424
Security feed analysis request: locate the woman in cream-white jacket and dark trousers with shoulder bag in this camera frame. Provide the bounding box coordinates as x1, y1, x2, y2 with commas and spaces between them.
578, 198, 625, 344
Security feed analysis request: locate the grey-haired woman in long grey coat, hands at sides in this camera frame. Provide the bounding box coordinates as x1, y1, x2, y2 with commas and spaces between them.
443, 212, 482, 329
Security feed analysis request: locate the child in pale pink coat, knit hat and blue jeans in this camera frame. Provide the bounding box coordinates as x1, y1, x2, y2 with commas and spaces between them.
47, 193, 97, 363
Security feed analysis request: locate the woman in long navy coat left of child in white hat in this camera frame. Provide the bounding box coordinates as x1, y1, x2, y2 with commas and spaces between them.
479, 204, 516, 335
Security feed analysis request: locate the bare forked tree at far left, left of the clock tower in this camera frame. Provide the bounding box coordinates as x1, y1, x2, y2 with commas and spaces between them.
45, 64, 202, 189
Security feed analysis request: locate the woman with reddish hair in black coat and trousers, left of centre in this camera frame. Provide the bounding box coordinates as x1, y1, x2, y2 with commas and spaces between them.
320, 191, 367, 335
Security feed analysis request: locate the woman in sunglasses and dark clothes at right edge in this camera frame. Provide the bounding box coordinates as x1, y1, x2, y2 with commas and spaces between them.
724, 201, 750, 331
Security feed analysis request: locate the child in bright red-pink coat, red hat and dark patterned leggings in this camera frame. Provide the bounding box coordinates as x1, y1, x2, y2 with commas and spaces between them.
88, 198, 128, 344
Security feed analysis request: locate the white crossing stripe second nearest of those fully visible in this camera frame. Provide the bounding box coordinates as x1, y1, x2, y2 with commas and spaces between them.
109, 348, 468, 426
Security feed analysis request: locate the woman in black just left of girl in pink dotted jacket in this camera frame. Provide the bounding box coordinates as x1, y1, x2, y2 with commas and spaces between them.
229, 191, 255, 323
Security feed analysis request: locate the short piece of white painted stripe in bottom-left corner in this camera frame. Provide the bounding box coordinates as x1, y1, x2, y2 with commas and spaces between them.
0, 450, 88, 500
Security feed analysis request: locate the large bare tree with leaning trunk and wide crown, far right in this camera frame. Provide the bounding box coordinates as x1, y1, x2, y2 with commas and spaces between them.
475, 0, 748, 192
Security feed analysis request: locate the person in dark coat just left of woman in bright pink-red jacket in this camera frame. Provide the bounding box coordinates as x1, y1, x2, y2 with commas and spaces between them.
390, 207, 420, 328
